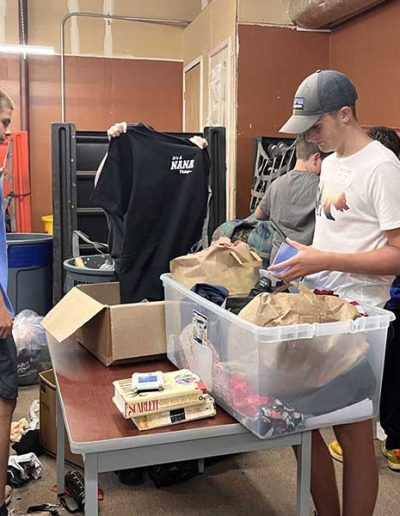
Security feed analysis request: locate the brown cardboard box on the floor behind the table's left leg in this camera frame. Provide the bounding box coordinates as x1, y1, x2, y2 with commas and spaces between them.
39, 369, 83, 468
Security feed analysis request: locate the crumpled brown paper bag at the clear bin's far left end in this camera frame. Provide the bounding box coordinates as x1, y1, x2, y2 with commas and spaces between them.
170, 239, 262, 295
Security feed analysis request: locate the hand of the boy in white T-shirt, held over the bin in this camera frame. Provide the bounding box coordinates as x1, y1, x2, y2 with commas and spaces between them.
268, 238, 330, 281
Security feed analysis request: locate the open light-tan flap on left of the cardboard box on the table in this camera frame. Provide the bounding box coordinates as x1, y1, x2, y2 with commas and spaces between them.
42, 287, 106, 342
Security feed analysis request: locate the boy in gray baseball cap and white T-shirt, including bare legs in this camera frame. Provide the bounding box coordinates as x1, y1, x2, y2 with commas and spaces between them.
270, 70, 400, 516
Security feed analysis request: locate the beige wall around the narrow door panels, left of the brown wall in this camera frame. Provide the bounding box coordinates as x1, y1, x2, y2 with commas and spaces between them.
183, 0, 237, 216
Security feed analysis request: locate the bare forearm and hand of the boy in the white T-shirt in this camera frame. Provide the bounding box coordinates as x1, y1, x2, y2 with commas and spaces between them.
268, 228, 400, 281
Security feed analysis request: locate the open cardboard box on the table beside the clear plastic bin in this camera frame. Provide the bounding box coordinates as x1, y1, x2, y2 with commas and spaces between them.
42, 283, 167, 366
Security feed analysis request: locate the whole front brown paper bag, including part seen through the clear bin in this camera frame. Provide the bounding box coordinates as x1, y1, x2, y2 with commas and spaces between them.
239, 284, 369, 396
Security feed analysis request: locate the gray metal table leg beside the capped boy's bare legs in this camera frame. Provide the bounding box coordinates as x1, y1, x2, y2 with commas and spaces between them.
297, 432, 312, 516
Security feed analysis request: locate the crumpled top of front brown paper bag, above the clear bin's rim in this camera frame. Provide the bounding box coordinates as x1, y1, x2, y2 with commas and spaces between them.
239, 283, 360, 326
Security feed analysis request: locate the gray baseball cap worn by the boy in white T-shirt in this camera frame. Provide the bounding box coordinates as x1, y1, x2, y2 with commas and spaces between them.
279, 70, 358, 134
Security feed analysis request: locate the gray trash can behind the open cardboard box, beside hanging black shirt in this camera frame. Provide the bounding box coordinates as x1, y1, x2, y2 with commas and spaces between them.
64, 254, 117, 293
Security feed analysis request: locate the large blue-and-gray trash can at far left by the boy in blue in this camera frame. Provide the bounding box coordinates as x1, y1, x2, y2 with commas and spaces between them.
7, 233, 53, 315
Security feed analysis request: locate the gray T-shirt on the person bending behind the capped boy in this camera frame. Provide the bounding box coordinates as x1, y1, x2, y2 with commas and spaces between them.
260, 170, 319, 262
